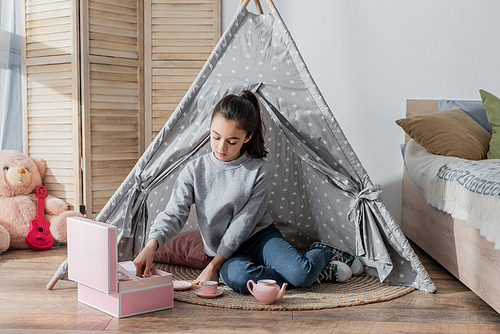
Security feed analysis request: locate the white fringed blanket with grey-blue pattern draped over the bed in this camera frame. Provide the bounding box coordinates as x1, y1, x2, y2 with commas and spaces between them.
405, 140, 500, 250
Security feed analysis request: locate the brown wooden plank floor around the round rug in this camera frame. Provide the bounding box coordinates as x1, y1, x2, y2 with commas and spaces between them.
0, 243, 500, 334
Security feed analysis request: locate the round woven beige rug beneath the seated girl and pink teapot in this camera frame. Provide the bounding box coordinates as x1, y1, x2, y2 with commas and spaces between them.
153, 263, 415, 311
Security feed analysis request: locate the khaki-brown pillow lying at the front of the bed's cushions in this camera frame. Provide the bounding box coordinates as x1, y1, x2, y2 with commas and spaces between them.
396, 108, 491, 160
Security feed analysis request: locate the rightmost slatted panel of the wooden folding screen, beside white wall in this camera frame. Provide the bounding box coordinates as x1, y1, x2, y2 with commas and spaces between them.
144, 0, 220, 143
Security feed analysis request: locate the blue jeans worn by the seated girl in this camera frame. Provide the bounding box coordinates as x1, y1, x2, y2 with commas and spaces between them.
219, 225, 332, 293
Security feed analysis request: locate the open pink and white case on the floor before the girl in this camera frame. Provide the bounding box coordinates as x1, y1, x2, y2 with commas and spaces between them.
67, 217, 174, 318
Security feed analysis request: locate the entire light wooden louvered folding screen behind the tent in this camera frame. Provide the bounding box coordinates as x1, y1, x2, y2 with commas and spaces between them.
21, 0, 220, 218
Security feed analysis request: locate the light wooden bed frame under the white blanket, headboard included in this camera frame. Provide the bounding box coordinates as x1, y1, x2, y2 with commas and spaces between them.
401, 100, 500, 313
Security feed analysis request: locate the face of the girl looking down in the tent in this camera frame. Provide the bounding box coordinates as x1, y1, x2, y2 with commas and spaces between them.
210, 116, 252, 162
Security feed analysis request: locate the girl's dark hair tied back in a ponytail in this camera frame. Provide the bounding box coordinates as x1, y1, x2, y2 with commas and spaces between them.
210, 90, 267, 158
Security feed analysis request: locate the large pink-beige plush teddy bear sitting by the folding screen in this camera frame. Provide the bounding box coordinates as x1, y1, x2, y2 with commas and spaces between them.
0, 150, 82, 254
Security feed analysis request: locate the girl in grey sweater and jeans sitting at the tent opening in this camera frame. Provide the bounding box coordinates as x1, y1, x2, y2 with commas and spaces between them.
134, 90, 362, 293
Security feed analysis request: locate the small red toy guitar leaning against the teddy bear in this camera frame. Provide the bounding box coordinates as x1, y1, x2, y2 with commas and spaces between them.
24, 186, 54, 250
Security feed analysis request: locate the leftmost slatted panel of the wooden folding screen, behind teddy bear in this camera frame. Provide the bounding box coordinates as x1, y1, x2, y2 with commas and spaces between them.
21, 0, 82, 210
